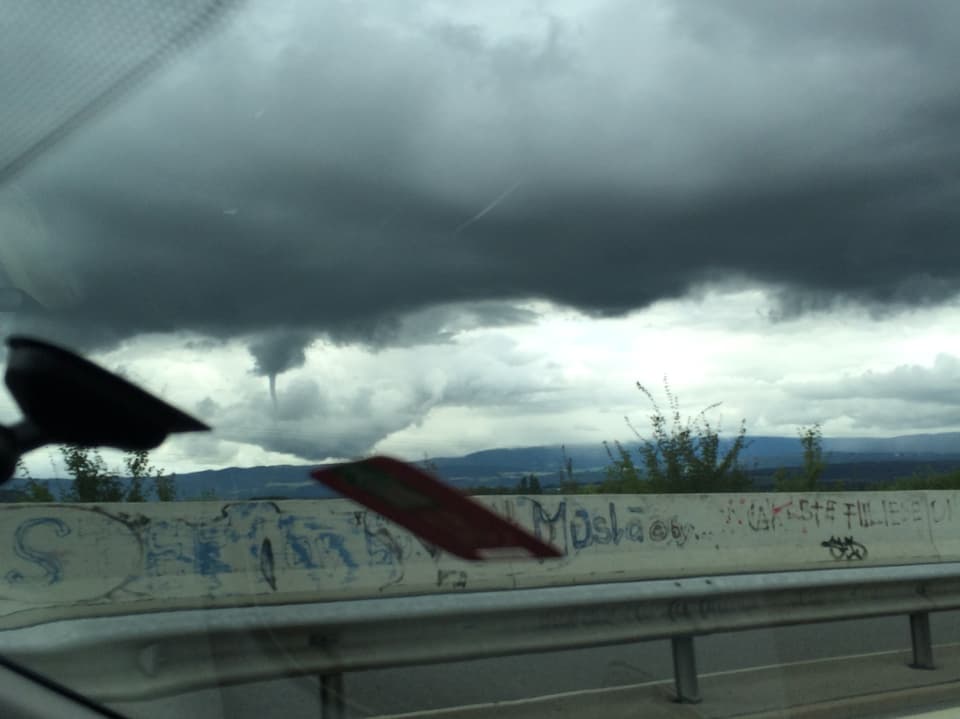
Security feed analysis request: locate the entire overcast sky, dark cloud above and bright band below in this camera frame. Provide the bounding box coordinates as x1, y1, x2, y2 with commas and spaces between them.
0, 0, 960, 473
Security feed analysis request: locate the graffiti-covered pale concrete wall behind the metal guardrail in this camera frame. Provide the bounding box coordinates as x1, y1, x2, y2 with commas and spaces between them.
0, 492, 960, 627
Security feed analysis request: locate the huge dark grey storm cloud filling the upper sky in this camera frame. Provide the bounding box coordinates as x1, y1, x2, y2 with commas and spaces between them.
0, 2, 960, 358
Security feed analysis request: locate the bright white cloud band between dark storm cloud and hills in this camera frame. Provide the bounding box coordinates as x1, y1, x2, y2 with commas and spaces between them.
0, 288, 960, 476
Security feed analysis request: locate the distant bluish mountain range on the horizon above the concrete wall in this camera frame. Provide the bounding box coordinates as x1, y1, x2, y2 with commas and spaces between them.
8, 432, 960, 500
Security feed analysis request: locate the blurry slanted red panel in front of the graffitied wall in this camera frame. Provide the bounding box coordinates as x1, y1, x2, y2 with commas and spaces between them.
310, 457, 563, 559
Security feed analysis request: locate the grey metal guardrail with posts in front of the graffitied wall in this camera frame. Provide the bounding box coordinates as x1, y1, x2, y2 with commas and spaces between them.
0, 563, 960, 716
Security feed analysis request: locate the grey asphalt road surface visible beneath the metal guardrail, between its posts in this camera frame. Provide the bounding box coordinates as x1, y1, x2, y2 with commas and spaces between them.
115, 612, 960, 719
